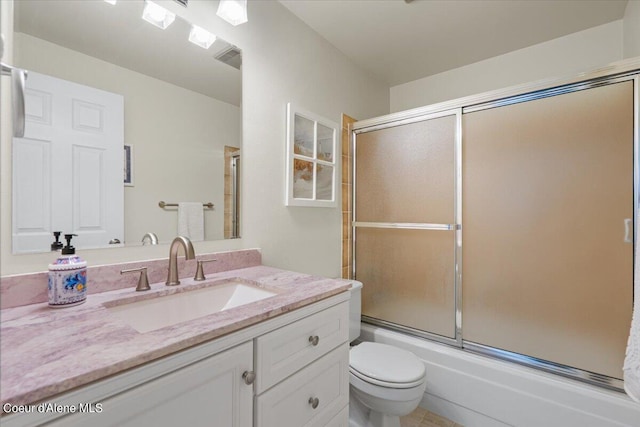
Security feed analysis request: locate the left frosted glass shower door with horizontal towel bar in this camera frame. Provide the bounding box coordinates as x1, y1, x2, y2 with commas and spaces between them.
353, 112, 460, 339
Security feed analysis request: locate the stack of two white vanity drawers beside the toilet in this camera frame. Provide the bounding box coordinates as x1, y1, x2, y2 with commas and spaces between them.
255, 303, 349, 427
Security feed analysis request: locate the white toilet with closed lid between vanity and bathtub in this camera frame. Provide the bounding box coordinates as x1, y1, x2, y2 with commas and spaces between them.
349, 281, 427, 427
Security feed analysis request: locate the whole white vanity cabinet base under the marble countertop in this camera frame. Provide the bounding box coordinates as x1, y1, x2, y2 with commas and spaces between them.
1, 292, 349, 427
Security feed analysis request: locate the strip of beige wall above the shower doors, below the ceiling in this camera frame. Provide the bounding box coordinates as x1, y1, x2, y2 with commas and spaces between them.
390, 20, 623, 112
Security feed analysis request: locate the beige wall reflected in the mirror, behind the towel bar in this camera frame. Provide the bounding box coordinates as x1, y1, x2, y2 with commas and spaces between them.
13, 33, 240, 244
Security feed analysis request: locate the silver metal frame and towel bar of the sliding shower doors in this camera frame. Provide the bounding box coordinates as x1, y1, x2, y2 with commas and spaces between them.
350, 58, 640, 391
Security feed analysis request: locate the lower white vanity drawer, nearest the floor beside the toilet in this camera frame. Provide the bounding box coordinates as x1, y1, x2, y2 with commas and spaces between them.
256, 343, 349, 427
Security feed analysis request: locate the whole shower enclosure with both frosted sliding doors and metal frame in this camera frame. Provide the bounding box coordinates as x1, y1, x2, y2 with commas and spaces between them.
352, 69, 639, 389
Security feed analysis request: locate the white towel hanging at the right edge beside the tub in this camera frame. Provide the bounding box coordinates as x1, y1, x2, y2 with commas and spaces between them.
623, 216, 640, 402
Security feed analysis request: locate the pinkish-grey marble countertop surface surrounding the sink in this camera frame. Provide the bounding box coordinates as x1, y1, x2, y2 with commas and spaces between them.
0, 266, 350, 405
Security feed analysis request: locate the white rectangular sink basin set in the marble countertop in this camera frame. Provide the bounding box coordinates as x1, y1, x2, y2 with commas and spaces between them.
108, 281, 277, 333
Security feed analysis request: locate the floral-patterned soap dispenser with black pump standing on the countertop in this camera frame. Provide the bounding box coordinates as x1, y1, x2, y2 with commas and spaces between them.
49, 234, 87, 307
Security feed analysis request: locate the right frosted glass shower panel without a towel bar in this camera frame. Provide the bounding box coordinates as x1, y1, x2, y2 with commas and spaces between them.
463, 81, 634, 378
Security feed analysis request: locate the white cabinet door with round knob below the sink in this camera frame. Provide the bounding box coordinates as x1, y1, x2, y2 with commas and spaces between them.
50, 342, 253, 427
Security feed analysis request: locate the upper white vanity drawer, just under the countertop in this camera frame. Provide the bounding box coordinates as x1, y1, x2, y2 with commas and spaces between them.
255, 301, 349, 394
